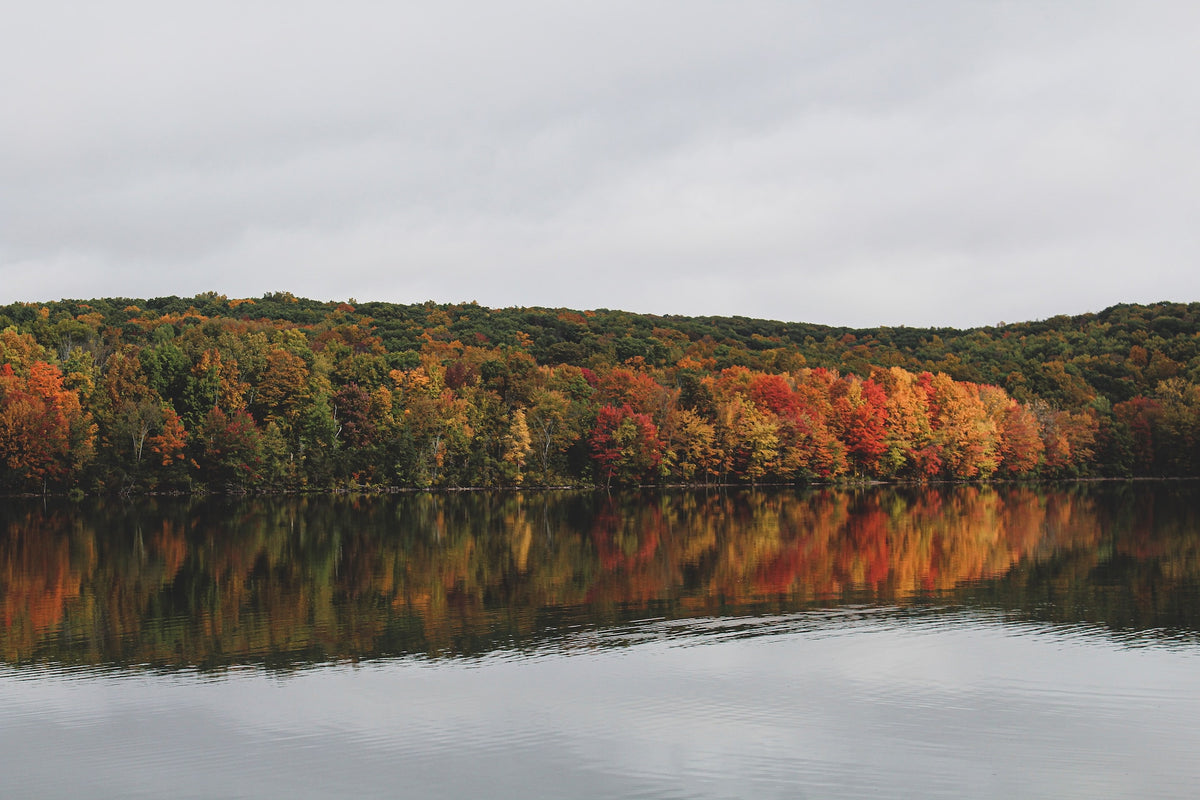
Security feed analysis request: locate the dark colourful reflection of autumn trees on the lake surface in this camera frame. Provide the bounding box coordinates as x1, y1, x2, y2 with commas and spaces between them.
0, 483, 1200, 667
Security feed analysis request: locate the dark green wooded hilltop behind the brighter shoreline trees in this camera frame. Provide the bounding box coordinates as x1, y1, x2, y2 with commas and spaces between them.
0, 293, 1200, 403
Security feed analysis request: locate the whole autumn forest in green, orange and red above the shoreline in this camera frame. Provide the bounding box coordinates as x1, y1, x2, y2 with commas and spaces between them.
0, 293, 1200, 494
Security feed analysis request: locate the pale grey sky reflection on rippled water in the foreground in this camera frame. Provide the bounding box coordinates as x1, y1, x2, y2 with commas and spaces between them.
0, 613, 1200, 798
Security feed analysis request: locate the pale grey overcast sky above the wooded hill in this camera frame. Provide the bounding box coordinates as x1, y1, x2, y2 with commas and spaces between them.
0, 0, 1200, 327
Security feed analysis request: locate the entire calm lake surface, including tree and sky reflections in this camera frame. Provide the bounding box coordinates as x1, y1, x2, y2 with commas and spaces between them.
0, 482, 1200, 798
